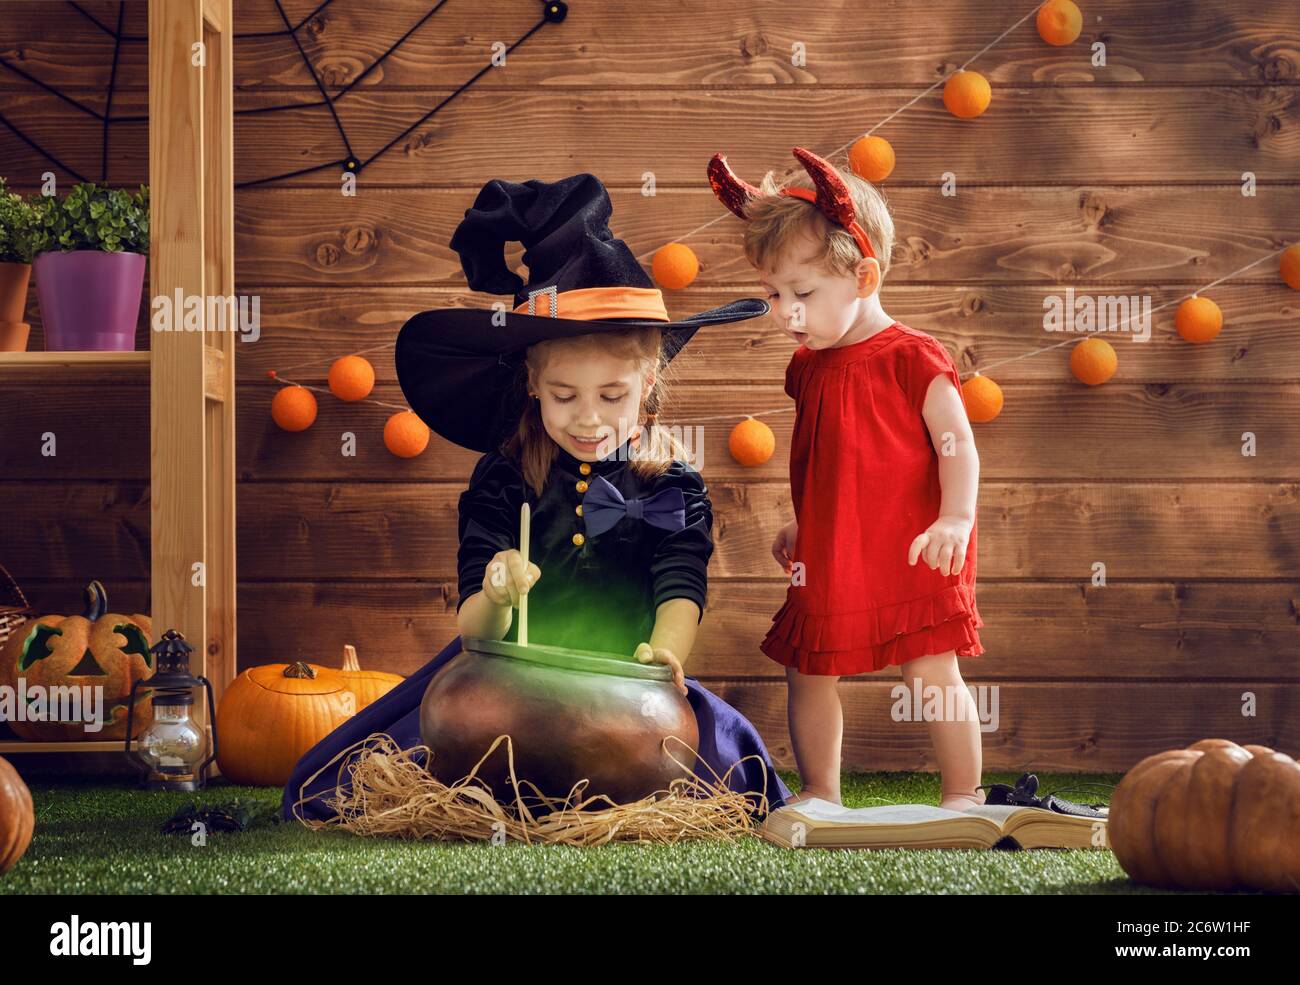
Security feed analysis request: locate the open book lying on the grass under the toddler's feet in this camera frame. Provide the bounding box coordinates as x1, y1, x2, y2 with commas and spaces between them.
761, 797, 1110, 849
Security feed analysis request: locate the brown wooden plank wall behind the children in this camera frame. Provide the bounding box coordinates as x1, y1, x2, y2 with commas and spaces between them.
0, 0, 1300, 769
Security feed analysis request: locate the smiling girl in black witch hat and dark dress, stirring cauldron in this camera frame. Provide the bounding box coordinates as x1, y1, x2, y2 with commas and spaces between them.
283, 174, 790, 820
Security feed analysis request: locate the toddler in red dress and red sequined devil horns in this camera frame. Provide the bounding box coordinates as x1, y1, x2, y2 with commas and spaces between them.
709, 147, 984, 810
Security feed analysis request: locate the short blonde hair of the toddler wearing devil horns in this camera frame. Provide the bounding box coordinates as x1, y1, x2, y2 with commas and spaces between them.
745, 166, 893, 278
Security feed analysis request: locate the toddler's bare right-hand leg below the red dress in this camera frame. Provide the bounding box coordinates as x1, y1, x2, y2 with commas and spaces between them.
900, 650, 984, 811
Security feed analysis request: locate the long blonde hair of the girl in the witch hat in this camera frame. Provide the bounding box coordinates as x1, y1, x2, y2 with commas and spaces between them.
502, 326, 689, 495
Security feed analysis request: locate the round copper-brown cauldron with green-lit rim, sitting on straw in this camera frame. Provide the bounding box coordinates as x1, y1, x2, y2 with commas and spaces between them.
420, 638, 699, 803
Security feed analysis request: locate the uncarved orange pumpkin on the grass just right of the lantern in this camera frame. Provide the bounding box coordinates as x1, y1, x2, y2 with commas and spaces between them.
217, 661, 356, 786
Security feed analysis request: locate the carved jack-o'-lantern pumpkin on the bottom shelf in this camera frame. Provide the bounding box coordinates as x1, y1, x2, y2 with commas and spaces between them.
0, 581, 153, 742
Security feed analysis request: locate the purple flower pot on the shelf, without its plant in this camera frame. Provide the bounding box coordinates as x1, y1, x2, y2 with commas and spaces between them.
31, 249, 144, 352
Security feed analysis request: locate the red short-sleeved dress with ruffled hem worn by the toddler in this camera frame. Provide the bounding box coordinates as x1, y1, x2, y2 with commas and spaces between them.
759, 321, 984, 674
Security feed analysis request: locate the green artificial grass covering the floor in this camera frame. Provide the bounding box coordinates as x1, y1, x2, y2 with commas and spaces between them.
0, 772, 1175, 895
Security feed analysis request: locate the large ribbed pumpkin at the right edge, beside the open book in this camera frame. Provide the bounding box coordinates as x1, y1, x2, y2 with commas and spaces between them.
1106, 739, 1300, 891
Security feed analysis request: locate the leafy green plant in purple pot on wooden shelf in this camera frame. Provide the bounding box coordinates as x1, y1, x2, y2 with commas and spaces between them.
31, 182, 150, 351
